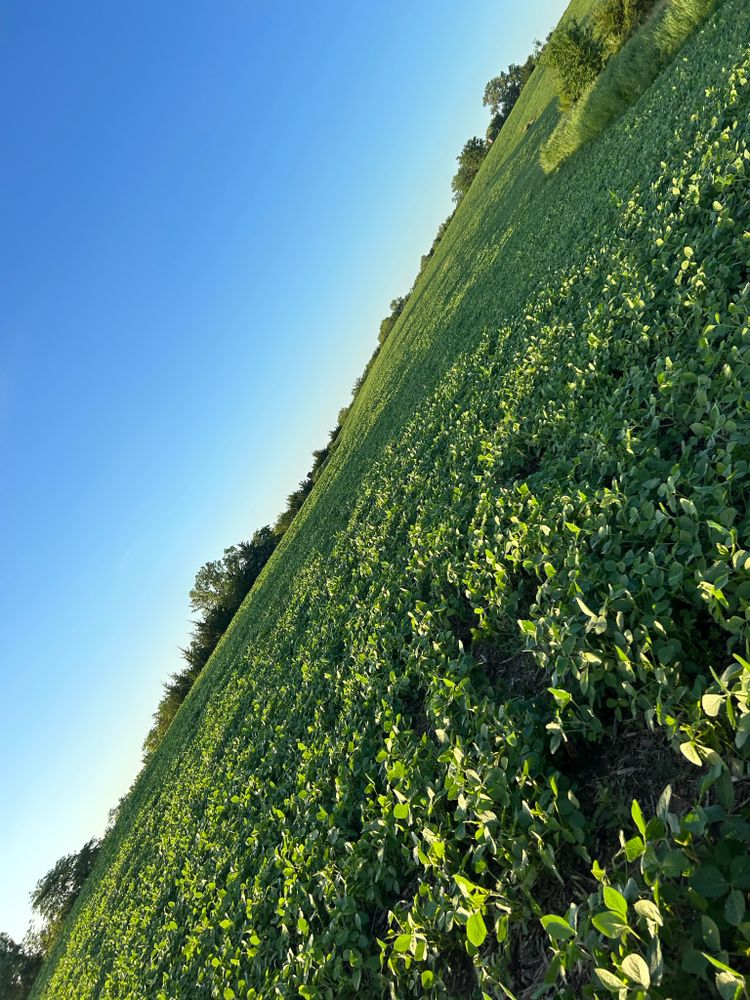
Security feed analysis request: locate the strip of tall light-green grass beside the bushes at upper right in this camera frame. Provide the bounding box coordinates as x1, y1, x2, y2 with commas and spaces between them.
542, 0, 717, 172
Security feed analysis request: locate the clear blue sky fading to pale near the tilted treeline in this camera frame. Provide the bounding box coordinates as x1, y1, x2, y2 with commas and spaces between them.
0, 0, 565, 939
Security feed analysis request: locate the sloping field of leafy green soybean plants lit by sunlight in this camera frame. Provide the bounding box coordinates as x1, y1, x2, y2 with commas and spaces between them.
29, 0, 750, 1000
